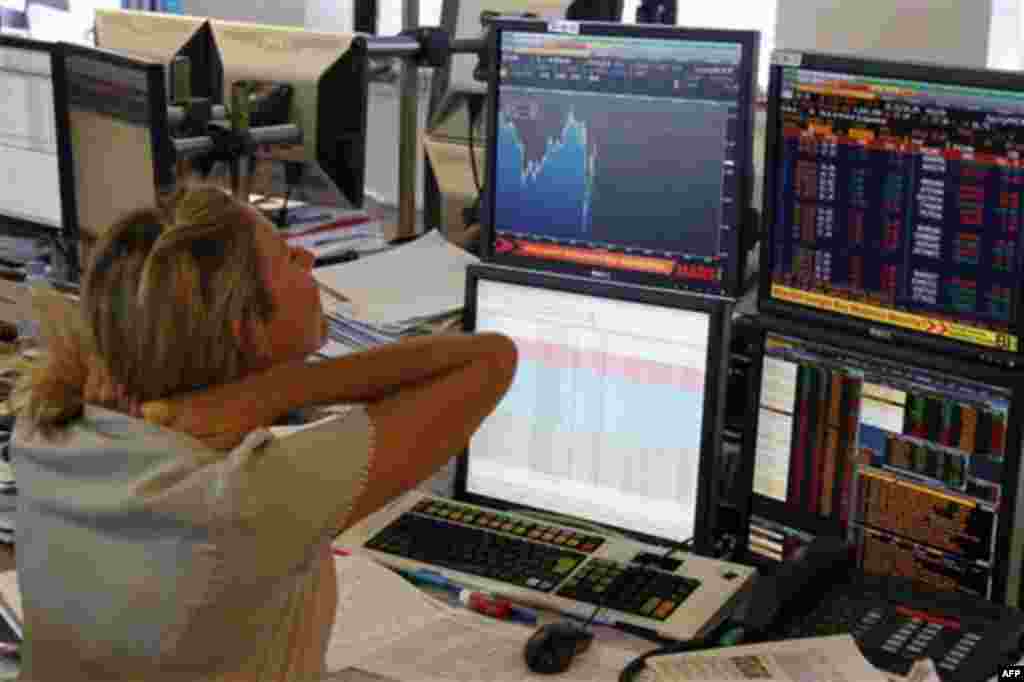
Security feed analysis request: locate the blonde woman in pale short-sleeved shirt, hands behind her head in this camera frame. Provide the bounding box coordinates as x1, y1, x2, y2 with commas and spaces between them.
11, 183, 516, 682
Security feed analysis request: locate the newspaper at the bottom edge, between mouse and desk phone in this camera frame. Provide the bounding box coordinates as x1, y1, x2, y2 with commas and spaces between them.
647, 635, 888, 682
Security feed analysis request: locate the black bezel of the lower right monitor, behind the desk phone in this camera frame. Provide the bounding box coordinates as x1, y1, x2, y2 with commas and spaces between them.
735, 314, 1024, 602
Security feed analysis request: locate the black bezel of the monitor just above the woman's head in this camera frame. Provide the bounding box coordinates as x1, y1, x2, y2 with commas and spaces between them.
55, 42, 177, 253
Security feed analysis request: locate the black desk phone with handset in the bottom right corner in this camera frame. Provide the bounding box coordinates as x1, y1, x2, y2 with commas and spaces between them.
743, 538, 1024, 682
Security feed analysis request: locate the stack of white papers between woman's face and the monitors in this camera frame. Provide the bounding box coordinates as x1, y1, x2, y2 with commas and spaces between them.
313, 230, 479, 356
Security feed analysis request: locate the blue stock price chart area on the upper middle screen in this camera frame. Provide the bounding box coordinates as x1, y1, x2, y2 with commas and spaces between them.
495, 90, 729, 258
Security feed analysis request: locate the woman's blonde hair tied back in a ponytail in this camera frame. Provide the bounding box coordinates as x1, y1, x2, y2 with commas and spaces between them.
25, 186, 273, 426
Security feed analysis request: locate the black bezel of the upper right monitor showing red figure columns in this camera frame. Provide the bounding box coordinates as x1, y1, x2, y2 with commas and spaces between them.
758, 51, 1024, 367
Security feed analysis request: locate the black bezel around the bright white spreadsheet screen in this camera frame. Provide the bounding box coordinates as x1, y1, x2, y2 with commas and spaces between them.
455, 263, 733, 555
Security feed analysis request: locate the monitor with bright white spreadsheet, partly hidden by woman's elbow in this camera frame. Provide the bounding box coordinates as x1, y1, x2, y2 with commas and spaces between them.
456, 260, 732, 553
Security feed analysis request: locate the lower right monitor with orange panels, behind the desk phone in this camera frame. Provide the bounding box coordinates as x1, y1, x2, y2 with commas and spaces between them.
743, 316, 1024, 604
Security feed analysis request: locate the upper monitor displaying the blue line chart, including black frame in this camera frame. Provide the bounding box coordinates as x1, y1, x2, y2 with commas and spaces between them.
481, 19, 759, 295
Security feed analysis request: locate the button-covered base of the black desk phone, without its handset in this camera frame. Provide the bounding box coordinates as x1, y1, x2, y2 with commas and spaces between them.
779, 576, 1024, 682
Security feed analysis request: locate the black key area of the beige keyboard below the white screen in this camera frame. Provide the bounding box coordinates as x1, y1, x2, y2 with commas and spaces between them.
366, 501, 700, 621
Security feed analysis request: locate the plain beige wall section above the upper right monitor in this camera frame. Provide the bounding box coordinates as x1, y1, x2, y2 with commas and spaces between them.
775, 0, 992, 67
